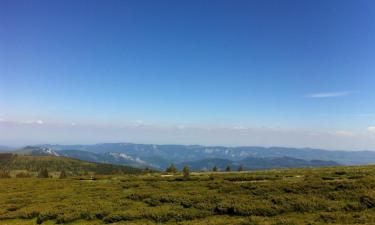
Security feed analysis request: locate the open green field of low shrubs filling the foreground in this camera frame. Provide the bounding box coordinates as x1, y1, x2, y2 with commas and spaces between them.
0, 166, 375, 225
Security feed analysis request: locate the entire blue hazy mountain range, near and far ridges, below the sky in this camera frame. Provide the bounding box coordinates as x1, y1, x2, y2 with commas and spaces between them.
3, 143, 375, 170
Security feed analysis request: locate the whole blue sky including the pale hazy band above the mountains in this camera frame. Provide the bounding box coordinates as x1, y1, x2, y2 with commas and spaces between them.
0, 0, 375, 150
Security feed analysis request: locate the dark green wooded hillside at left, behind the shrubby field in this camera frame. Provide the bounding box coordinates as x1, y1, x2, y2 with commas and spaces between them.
0, 153, 141, 175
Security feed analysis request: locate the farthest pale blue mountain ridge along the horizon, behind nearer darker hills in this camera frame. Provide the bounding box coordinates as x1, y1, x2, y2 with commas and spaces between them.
43, 143, 375, 165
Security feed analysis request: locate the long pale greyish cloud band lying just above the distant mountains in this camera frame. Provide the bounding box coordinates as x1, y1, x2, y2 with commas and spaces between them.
0, 120, 375, 150
